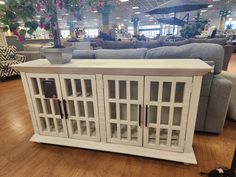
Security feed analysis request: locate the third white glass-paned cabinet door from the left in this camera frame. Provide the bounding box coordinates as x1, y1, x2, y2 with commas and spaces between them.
103, 75, 143, 146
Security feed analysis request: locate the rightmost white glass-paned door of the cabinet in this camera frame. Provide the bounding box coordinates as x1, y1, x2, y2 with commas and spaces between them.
144, 76, 192, 152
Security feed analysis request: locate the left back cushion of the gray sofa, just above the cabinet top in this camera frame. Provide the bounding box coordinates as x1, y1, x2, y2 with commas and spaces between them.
94, 48, 147, 59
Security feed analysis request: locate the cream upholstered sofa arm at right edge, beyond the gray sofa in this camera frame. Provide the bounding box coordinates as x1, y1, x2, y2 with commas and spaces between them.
221, 71, 236, 120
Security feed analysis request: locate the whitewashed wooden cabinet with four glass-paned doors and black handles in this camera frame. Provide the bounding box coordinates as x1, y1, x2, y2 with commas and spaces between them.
14, 59, 212, 164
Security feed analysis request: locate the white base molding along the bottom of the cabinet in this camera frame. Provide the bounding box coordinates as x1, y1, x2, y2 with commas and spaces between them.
30, 134, 197, 164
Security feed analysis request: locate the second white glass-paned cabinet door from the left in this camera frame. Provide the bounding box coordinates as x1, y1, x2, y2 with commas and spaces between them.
60, 74, 100, 141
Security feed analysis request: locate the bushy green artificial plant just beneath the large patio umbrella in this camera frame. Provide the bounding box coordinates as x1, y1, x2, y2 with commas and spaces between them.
180, 13, 208, 38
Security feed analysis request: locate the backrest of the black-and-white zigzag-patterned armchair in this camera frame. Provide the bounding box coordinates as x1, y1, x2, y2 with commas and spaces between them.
0, 46, 16, 61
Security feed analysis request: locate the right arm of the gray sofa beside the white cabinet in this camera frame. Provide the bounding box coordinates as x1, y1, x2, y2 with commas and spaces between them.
205, 74, 232, 133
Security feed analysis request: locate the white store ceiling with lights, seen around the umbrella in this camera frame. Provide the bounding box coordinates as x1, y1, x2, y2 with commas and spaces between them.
60, 0, 236, 28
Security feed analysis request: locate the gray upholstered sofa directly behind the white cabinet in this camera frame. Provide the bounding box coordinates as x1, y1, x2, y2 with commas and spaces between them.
73, 43, 232, 134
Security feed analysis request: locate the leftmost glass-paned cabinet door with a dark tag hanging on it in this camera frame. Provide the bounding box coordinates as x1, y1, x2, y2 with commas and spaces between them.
27, 73, 68, 137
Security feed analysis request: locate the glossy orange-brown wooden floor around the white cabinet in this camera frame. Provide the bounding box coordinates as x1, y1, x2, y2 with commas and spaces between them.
0, 57, 236, 177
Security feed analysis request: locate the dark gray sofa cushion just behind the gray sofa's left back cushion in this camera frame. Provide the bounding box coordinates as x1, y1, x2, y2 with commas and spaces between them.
102, 41, 134, 49
